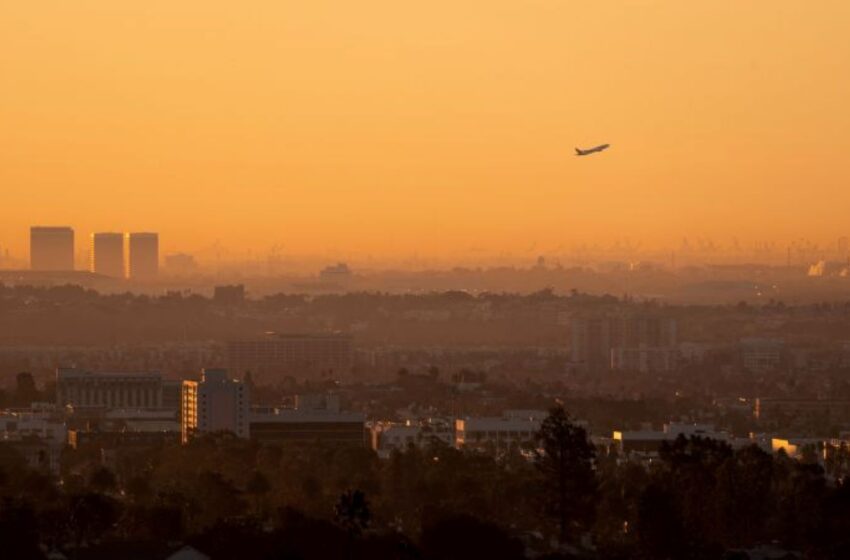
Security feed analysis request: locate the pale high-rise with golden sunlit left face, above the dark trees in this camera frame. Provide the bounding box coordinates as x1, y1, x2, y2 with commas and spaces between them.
181, 369, 251, 443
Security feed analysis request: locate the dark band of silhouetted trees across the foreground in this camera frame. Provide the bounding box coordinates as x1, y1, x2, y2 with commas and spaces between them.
0, 407, 850, 560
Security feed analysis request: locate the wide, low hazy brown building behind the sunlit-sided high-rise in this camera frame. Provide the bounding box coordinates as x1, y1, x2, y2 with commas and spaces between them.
227, 333, 353, 381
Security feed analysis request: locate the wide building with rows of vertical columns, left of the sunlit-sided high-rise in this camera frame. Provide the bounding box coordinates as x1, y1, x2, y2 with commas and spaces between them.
56, 368, 163, 408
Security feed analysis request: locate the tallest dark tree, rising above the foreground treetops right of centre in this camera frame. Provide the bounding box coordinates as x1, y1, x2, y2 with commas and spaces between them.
535, 405, 597, 542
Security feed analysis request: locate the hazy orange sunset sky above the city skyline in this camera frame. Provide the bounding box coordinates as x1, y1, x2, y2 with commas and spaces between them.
0, 0, 850, 262
